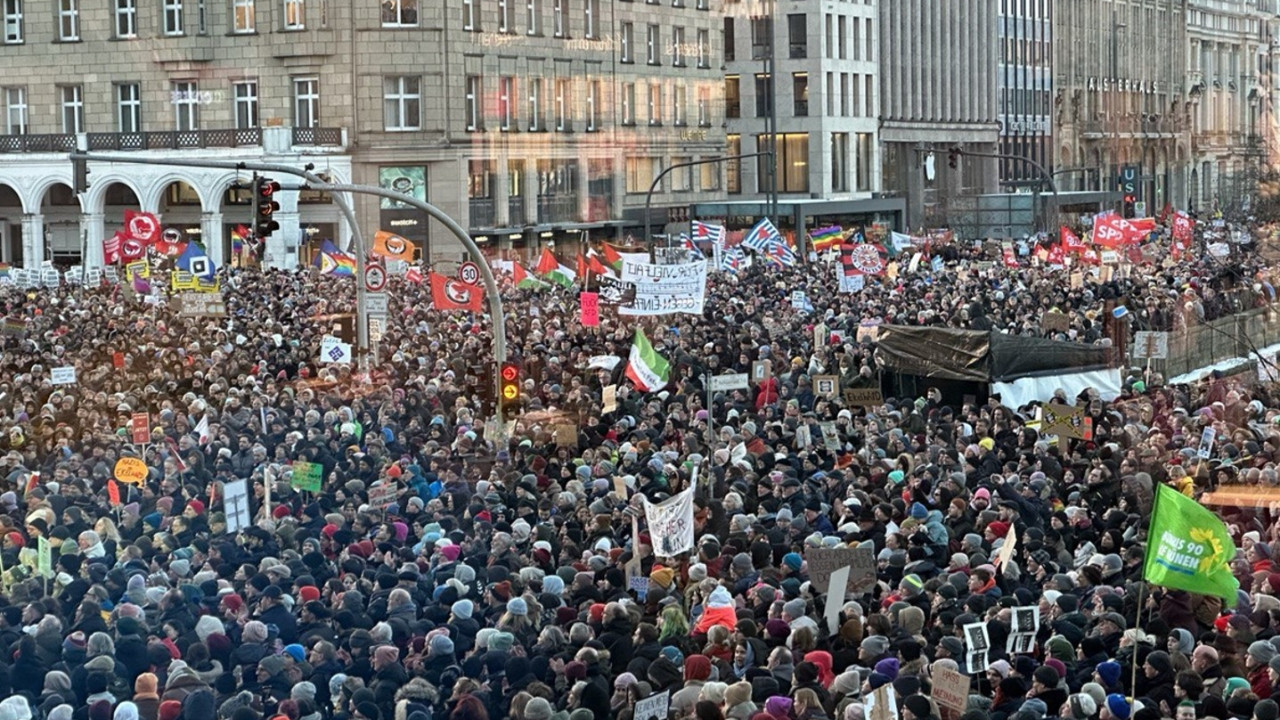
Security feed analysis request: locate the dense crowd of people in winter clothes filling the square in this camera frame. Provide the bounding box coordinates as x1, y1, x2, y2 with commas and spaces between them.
0, 225, 1280, 720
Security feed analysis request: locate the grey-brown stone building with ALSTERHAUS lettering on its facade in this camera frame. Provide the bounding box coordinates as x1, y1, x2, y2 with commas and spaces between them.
1052, 0, 1190, 211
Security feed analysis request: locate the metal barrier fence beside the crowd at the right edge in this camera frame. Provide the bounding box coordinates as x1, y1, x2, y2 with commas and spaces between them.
1130, 305, 1280, 379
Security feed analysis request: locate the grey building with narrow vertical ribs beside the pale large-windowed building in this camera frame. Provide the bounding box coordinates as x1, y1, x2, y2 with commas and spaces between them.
877, 0, 1000, 231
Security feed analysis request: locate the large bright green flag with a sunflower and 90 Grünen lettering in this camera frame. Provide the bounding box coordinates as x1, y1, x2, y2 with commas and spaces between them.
1142, 484, 1240, 607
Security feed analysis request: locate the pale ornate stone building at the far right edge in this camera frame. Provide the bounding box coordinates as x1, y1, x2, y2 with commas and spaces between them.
1187, 0, 1276, 213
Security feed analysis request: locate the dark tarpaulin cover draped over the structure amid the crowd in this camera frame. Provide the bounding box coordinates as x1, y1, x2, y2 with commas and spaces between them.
876, 325, 1107, 383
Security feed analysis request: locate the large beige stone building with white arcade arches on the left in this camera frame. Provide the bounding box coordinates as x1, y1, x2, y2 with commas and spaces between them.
0, 0, 726, 266
